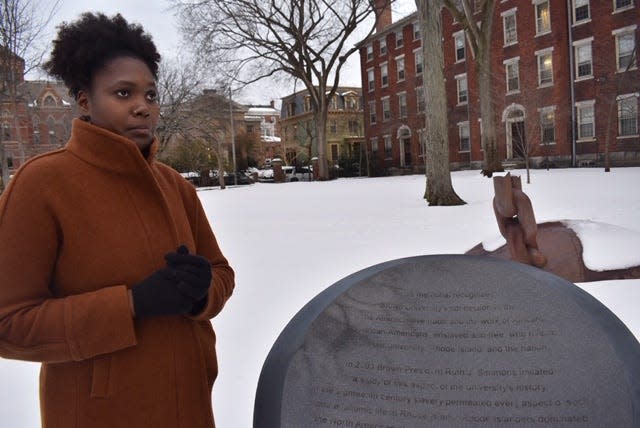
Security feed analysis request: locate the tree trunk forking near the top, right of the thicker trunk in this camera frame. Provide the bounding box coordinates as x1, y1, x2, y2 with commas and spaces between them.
442, 0, 503, 177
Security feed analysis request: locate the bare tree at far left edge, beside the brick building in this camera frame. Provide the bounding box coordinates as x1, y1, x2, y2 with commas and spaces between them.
0, 0, 60, 191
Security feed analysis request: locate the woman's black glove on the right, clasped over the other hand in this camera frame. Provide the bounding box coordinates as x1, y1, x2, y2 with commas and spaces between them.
165, 245, 212, 313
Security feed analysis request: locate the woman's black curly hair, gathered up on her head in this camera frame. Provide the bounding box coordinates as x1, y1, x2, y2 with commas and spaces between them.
43, 12, 160, 98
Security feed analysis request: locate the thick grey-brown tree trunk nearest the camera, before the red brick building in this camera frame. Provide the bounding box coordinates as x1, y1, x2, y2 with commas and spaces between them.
416, 0, 465, 205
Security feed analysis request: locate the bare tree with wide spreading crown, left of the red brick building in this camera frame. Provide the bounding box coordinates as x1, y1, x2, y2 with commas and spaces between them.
174, 0, 393, 179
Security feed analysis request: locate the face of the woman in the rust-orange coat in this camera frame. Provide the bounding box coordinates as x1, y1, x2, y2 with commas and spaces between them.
78, 56, 160, 150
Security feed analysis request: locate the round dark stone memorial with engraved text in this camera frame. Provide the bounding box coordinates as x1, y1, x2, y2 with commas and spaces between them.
254, 255, 640, 428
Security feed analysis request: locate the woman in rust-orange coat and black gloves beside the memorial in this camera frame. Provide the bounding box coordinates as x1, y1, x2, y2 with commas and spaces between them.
0, 14, 234, 428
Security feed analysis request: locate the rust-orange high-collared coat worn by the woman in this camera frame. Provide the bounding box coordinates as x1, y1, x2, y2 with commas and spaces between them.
0, 119, 234, 428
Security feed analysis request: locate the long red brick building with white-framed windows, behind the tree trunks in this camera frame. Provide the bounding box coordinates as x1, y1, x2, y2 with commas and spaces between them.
360, 0, 640, 172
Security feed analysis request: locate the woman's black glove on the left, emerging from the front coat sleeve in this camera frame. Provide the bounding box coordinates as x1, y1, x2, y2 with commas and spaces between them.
131, 268, 198, 318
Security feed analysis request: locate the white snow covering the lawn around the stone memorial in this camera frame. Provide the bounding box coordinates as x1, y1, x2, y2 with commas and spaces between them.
0, 168, 640, 428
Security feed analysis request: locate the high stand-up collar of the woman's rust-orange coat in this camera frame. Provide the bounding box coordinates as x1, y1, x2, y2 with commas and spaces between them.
66, 119, 158, 174
